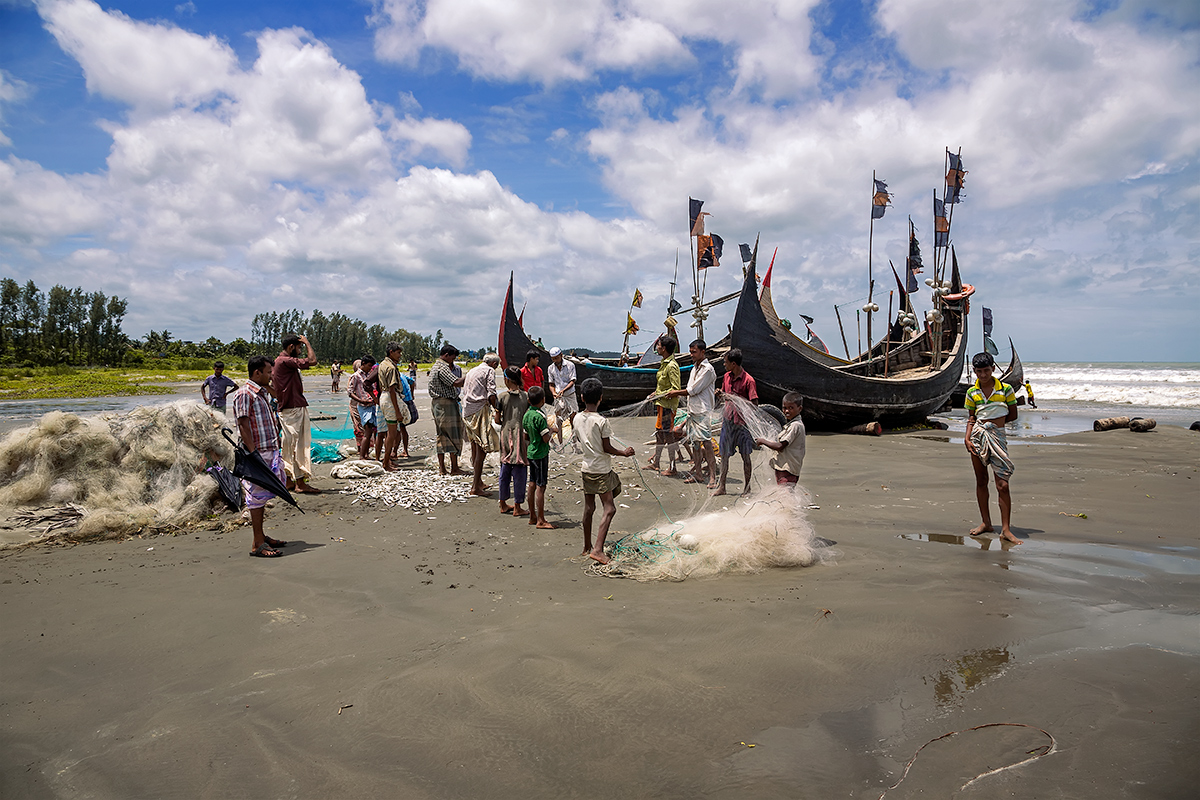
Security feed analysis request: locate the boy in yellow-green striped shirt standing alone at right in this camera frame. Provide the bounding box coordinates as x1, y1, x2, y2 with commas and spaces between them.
964, 353, 1021, 545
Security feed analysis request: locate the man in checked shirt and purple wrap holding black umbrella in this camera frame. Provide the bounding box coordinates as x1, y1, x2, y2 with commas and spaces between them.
233, 355, 287, 558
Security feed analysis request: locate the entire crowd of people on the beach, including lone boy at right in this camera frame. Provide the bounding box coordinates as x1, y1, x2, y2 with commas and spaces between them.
211, 335, 1020, 564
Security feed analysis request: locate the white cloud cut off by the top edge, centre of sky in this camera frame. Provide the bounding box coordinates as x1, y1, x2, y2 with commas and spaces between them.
368, 0, 817, 96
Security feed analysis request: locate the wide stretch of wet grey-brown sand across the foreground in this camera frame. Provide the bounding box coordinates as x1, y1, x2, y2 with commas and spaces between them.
0, 420, 1200, 798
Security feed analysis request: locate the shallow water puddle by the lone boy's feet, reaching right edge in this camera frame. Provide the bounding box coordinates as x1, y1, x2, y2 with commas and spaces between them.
899, 534, 1200, 581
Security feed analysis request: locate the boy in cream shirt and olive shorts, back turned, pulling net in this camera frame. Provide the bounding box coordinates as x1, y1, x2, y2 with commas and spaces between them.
574, 378, 634, 564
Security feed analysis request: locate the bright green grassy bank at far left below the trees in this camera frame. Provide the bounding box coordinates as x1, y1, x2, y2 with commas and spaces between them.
0, 366, 180, 401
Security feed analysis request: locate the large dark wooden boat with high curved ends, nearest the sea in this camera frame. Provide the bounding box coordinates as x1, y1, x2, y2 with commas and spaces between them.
731, 248, 974, 431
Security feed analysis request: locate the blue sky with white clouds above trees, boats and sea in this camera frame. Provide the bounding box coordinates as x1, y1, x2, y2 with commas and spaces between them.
0, 0, 1200, 361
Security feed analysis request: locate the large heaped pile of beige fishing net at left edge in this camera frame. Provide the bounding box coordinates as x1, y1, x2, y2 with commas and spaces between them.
0, 401, 233, 540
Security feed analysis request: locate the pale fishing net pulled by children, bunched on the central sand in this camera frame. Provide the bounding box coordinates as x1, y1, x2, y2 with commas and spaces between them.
587, 396, 836, 581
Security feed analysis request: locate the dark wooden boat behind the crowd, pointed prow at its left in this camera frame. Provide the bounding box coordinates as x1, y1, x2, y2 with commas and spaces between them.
497, 275, 710, 409
